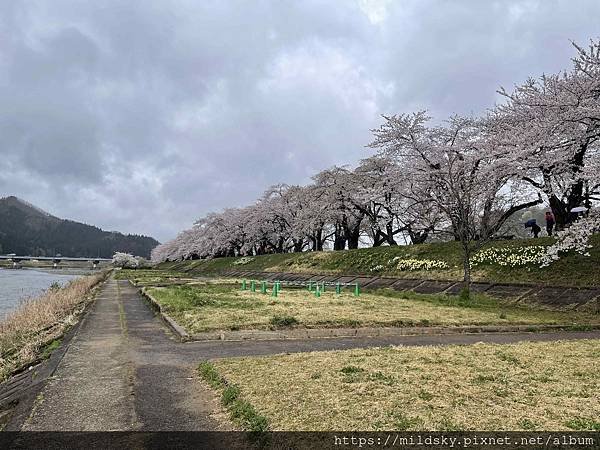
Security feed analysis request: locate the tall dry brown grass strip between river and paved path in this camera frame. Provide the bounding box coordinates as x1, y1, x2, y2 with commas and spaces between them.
0, 272, 106, 381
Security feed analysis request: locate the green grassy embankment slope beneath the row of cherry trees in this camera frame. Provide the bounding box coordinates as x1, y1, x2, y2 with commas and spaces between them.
159, 235, 600, 286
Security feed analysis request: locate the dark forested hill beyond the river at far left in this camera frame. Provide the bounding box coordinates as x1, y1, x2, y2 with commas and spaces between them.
0, 197, 158, 258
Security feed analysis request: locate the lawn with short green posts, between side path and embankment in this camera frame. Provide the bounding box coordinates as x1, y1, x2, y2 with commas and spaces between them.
144, 282, 600, 334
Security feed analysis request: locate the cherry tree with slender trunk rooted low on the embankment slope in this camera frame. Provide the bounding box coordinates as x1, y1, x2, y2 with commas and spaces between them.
370, 111, 541, 291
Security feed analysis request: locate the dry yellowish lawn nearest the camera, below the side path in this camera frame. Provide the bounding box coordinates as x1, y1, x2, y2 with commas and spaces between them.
200, 340, 600, 431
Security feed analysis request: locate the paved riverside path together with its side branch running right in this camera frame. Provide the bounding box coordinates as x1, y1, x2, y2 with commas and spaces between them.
18, 279, 600, 431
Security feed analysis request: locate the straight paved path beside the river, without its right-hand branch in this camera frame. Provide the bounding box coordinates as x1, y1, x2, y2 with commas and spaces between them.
23, 279, 219, 431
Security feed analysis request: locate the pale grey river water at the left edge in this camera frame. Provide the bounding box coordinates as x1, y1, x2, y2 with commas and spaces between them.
0, 269, 89, 320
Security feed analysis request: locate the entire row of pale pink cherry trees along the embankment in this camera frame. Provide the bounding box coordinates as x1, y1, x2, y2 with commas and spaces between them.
153, 41, 600, 288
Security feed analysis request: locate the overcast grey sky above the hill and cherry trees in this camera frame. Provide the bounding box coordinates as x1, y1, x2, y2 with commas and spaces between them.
0, 0, 600, 241
